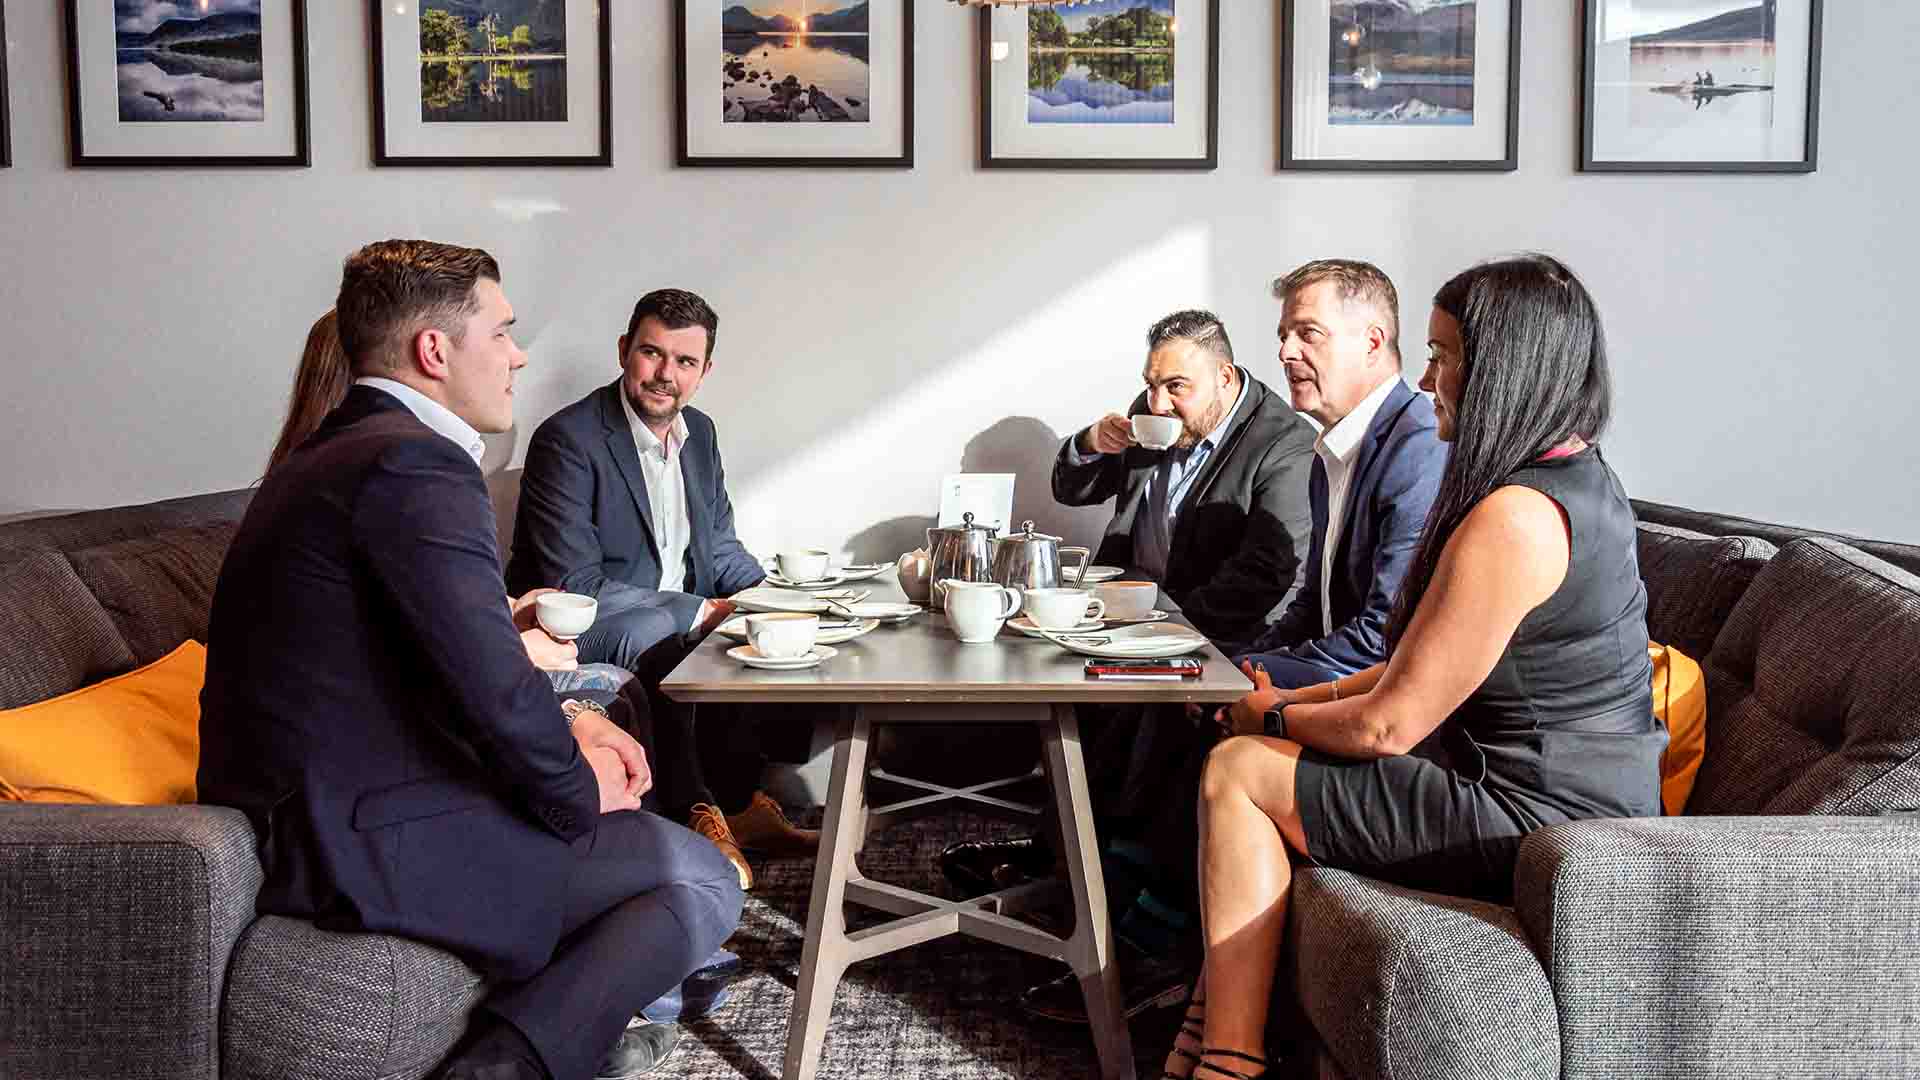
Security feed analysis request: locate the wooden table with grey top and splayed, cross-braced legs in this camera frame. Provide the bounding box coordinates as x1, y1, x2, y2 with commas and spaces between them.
660, 573, 1252, 1080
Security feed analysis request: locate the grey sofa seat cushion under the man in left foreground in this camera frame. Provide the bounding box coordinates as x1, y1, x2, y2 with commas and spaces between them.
221, 915, 486, 1080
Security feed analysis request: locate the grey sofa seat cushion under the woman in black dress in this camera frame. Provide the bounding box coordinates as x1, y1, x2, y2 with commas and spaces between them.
1288, 869, 1561, 1080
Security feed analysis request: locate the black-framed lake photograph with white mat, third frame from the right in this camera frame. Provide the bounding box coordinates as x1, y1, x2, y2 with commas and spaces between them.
979, 0, 1219, 169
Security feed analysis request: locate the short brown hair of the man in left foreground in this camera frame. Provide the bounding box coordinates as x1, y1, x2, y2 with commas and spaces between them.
334, 240, 499, 371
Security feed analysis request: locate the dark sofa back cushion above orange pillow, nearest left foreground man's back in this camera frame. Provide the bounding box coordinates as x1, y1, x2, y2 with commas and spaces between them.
67, 523, 236, 663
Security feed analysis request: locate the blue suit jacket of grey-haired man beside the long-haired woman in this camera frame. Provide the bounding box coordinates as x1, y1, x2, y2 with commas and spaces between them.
1248, 380, 1448, 676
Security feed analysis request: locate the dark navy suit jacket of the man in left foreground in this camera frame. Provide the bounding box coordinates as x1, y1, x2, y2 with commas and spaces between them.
200, 386, 599, 978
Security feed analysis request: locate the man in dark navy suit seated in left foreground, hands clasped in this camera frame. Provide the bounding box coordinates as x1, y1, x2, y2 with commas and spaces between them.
198, 240, 741, 1080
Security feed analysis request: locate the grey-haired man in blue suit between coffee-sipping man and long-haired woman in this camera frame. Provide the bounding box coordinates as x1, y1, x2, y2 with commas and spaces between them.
1023, 259, 1446, 1022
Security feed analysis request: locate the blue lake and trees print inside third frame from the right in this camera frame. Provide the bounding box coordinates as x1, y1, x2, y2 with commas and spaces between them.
1027, 0, 1175, 125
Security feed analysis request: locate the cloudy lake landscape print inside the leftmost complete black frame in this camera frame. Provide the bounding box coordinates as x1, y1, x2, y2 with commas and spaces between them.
113, 0, 267, 123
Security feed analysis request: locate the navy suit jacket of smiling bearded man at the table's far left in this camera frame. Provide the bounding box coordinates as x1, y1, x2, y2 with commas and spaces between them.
507, 380, 766, 628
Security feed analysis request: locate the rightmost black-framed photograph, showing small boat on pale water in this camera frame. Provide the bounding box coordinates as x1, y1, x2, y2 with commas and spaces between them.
1580, 0, 1822, 173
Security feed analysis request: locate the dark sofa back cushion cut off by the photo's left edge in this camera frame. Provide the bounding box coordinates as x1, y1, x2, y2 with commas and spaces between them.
0, 550, 134, 709
